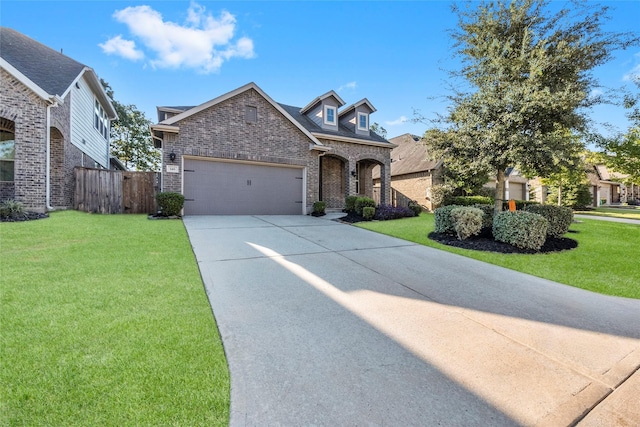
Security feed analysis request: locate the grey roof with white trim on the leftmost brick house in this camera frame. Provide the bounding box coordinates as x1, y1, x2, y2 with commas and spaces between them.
0, 27, 116, 119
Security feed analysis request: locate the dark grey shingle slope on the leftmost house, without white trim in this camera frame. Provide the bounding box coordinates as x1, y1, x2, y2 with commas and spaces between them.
0, 27, 85, 96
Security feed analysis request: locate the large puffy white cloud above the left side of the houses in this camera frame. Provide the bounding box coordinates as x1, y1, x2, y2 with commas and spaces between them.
101, 2, 255, 73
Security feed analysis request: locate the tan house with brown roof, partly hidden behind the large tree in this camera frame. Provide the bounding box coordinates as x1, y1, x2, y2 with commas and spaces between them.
373, 133, 442, 210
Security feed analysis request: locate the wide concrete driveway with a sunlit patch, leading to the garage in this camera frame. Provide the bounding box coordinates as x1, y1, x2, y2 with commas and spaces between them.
184, 216, 640, 426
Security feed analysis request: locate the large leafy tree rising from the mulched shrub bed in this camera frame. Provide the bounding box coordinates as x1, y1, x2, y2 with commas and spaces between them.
427, 0, 634, 210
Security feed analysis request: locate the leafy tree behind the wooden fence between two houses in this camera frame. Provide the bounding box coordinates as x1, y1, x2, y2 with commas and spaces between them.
100, 80, 160, 171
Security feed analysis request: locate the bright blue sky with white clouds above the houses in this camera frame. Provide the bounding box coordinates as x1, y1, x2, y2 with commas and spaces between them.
0, 0, 640, 137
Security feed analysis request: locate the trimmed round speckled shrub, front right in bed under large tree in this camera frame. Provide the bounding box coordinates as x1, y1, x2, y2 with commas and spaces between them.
493, 211, 549, 251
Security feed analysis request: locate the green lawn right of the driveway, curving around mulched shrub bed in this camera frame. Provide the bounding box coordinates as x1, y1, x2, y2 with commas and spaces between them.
357, 213, 640, 299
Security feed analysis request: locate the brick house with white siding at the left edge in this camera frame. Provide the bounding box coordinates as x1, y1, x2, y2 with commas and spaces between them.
0, 27, 116, 212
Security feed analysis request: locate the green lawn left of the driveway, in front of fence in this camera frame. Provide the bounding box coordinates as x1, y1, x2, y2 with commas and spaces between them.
0, 211, 229, 426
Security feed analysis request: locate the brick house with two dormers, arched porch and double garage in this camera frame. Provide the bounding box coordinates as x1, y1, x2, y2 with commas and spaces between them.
151, 83, 395, 215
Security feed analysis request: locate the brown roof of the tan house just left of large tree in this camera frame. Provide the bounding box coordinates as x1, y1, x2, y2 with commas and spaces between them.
373, 133, 442, 179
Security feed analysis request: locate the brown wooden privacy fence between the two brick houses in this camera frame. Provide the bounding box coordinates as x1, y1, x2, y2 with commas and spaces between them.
74, 168, 159, 214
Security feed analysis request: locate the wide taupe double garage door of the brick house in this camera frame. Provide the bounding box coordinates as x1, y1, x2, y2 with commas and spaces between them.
184, 159, 304, 215
